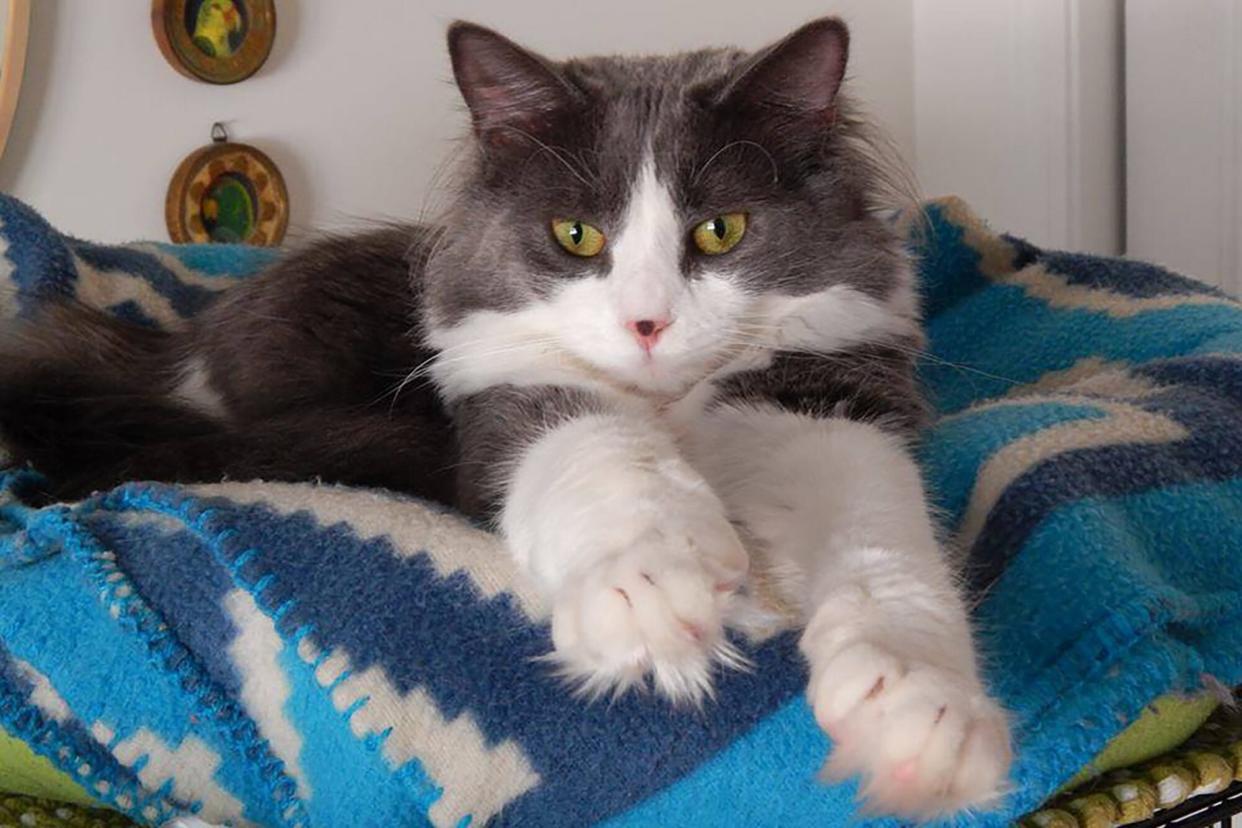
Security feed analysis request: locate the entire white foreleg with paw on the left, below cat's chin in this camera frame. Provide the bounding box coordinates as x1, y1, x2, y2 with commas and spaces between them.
501, 415, 748, 701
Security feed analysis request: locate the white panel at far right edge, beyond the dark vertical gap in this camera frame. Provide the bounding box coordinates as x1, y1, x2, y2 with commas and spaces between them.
1125, 0, 1242, 294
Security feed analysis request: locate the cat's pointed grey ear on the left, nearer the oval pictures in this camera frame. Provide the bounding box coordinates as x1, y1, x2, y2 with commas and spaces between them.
448, 21, 579, 148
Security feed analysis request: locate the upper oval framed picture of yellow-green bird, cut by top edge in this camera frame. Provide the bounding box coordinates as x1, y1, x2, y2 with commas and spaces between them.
152, 0, 276, 83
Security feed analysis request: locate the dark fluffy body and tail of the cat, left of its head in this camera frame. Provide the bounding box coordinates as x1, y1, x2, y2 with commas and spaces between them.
0, 227, 452, 500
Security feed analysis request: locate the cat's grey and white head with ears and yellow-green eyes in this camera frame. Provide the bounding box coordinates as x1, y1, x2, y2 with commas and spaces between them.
425, 19, 913, 397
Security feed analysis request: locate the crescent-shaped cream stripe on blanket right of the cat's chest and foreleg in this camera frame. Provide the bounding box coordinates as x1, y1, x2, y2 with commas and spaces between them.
958, 397, 1187, 549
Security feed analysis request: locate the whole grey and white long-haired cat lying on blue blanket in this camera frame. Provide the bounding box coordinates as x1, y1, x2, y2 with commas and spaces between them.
0, 19, 1010, 818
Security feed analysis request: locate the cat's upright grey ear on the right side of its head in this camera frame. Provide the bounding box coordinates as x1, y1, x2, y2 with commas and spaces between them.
715, 17, 850, 125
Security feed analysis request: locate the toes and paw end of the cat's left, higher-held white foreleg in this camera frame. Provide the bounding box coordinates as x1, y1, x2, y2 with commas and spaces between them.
551, 515, 746, 704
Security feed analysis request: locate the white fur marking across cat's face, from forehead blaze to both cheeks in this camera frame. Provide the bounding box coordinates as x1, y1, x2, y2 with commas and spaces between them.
428, 156, 918, 400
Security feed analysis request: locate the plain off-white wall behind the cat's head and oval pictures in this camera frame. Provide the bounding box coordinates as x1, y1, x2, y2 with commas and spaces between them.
0, 0, 914, 241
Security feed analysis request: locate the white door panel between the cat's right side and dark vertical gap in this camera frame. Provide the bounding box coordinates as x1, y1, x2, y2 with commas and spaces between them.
914, 0, 1127, 253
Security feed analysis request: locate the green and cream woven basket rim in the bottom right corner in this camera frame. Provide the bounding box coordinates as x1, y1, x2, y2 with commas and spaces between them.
1018, 708, 1242, 828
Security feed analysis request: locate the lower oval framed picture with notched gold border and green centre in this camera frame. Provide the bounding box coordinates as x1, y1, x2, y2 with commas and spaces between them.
164, 142, 289, 246
